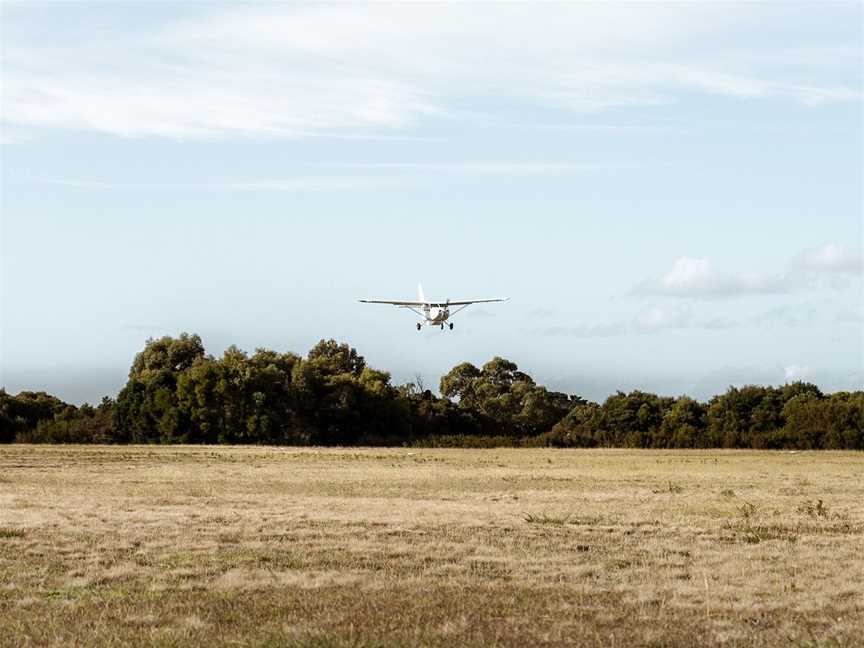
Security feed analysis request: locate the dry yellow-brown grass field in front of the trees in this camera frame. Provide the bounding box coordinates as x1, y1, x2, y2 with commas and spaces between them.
0, 445, 864, 647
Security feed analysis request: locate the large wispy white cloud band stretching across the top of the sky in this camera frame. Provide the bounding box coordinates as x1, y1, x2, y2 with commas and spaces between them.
2, 3, 860, 138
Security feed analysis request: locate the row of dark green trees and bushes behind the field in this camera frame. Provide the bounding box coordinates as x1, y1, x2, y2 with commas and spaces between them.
0, 333, 864, 450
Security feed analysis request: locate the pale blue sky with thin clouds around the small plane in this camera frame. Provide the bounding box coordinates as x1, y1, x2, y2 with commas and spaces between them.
0, 2, 864, 403
